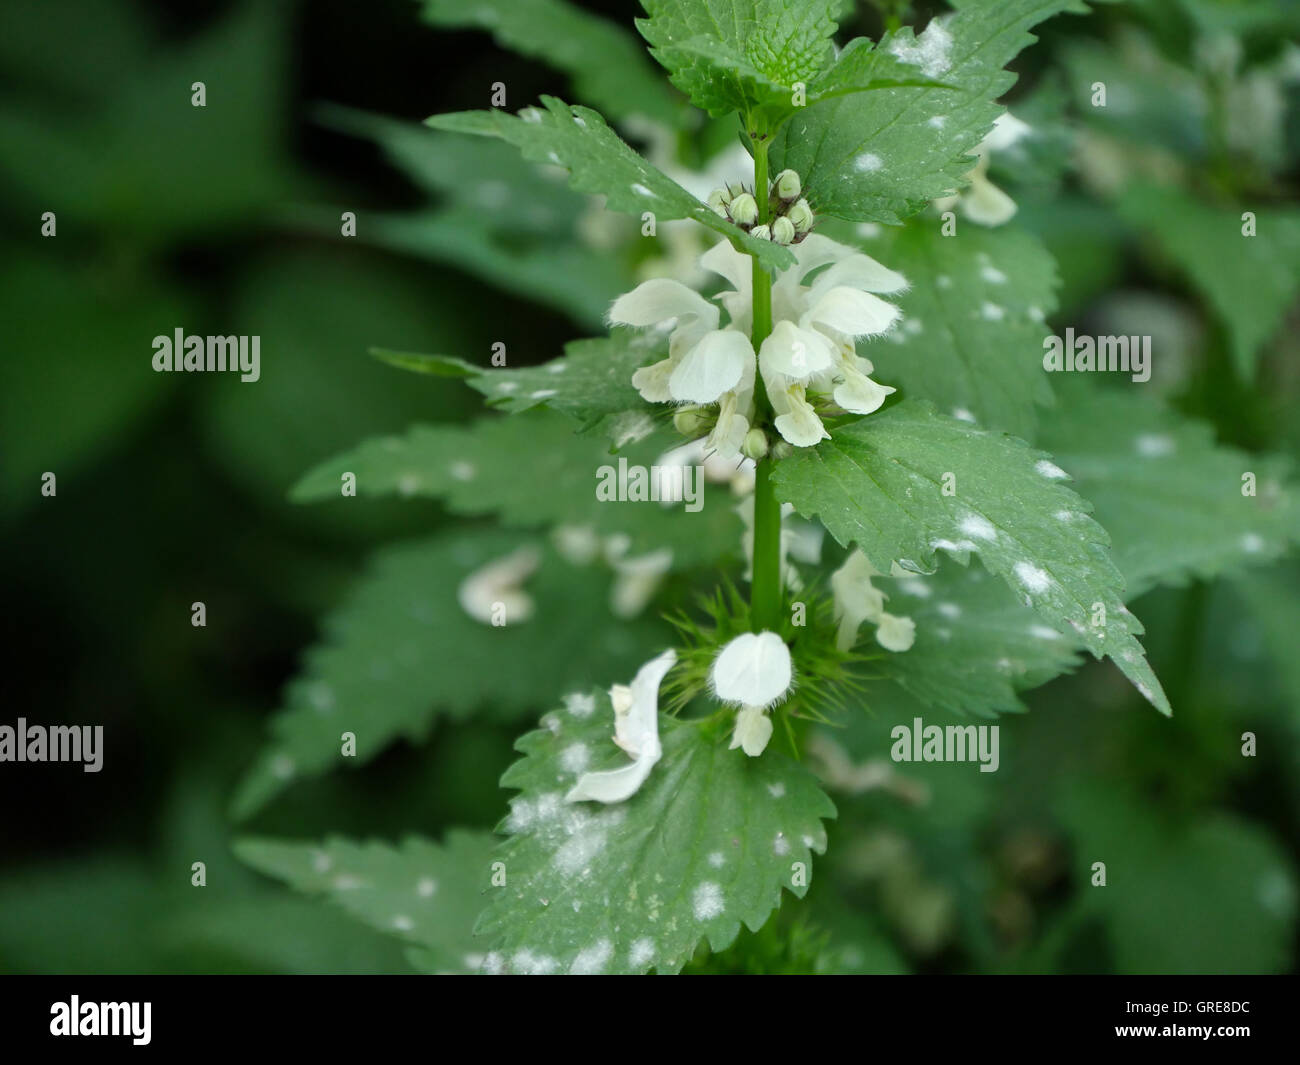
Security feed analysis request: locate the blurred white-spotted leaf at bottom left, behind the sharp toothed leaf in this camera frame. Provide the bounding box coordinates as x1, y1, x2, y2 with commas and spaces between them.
234, 830, 494, 973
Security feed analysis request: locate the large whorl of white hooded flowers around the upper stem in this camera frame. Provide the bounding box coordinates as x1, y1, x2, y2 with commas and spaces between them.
610, 233, 907, 459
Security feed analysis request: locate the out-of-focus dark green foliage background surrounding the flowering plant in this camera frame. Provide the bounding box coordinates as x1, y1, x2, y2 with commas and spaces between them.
0, 0, 1300, 973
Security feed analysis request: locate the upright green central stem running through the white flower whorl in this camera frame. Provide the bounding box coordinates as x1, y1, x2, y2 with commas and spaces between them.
749, 137, 781, 632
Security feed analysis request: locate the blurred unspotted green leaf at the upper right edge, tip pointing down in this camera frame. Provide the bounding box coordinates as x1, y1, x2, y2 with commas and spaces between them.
1119, 186, 1300, 381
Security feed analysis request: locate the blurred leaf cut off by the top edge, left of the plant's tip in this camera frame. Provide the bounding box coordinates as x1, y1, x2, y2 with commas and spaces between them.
421, 0, 681, 125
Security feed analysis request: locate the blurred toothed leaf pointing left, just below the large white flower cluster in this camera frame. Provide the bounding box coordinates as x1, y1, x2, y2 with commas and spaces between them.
291, 411, 741, 568
